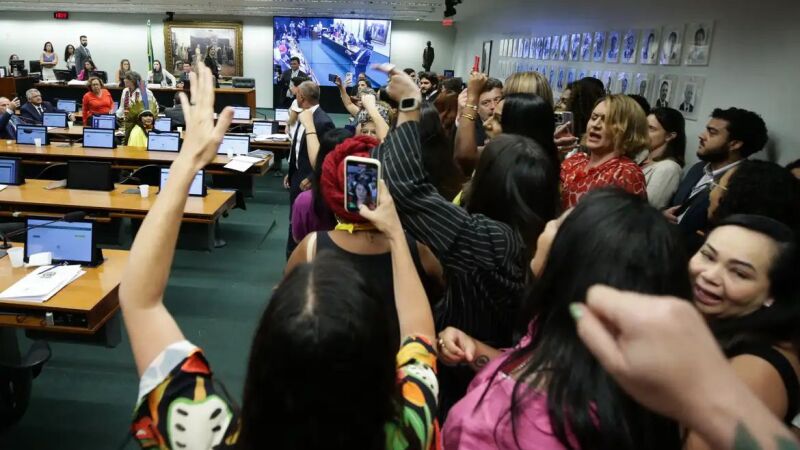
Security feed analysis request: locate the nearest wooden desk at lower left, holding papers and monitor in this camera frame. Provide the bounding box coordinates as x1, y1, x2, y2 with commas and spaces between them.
0, 244, 129, 334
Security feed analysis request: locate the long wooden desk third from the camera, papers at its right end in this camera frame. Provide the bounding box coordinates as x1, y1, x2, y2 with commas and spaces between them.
0, 135, 272, 176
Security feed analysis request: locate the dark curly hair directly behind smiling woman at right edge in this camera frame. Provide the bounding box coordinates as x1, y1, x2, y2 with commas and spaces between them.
711, 159, 800, 232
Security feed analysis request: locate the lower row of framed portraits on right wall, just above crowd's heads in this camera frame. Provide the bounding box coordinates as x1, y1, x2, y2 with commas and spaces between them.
500, 61, 706, 120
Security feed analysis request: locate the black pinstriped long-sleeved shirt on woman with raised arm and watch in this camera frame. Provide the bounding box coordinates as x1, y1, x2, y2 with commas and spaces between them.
373, 122, 529, 347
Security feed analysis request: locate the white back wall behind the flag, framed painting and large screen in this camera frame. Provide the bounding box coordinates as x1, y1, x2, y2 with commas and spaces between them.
0, 12, 455, 107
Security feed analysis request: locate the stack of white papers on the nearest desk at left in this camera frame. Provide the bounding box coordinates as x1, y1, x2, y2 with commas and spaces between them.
0, 265, 86, 303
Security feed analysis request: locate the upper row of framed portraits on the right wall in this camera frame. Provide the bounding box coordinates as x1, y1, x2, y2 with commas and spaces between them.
499, 21, 714, 66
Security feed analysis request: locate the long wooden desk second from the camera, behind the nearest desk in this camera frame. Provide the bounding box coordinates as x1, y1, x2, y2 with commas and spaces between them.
0, 179, 235, 224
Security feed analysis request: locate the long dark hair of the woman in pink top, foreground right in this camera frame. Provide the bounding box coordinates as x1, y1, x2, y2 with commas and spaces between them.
494, 188, 690, 450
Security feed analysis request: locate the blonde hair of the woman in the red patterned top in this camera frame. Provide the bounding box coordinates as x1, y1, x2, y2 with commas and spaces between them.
597, 94, 649, 156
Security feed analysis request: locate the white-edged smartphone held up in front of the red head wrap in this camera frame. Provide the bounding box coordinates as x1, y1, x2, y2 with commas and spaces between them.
344, 156, 381, 213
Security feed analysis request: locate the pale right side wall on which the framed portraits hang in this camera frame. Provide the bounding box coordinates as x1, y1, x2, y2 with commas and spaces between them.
453, 0, 800, 163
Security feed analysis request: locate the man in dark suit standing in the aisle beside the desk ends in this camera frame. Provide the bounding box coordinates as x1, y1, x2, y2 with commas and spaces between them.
283, 81, 336, 258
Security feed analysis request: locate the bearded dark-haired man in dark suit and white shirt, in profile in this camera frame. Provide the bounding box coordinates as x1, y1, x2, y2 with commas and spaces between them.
664, 108, 768, 250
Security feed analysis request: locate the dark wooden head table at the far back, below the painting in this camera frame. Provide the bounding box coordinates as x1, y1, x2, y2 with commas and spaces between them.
35, 83, 256, 117
